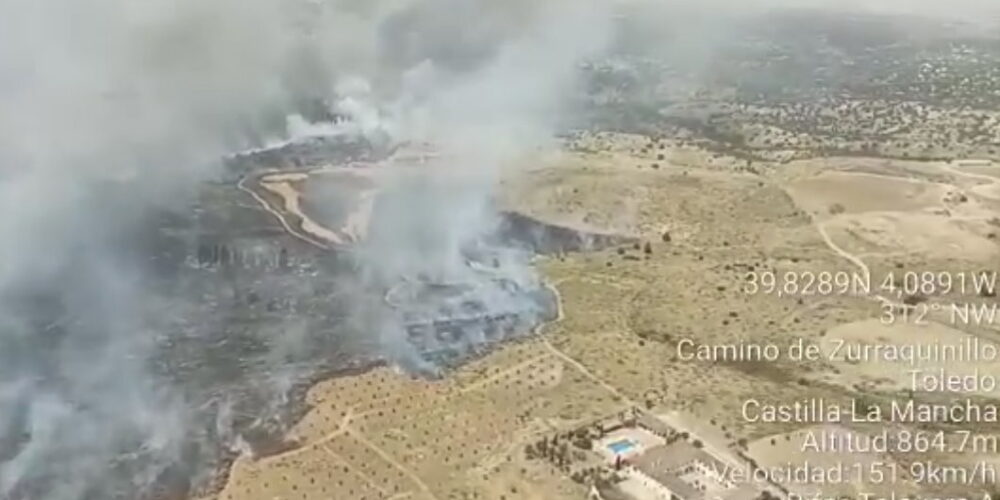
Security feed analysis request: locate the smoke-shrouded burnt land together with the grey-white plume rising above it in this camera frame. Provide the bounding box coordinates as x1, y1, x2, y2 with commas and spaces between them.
0, 0, 610, 500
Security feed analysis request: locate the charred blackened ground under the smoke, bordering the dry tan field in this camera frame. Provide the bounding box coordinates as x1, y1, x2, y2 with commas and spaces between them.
0, 139, 628, 500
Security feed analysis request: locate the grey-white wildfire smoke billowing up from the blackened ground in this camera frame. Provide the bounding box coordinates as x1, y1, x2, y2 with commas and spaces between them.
0, 0, 991, 500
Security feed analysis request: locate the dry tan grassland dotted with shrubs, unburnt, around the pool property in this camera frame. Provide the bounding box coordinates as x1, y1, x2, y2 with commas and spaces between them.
218, 134, 1000, 500
